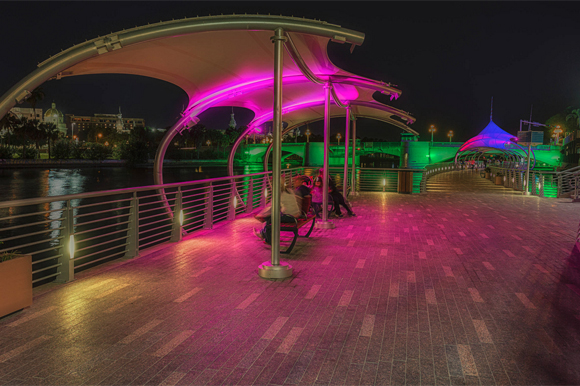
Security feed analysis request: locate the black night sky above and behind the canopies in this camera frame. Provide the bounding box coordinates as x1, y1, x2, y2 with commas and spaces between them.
0, 1, 580, 141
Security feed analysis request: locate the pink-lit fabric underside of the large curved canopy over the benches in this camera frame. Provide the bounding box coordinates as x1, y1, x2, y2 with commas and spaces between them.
63, 30, 414, 129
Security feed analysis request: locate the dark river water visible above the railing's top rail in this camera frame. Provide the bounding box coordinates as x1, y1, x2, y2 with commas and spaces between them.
0, 165, 263, 202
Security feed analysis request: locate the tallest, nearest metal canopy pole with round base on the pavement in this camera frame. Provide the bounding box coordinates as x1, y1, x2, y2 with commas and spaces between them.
258, 28, 292, 279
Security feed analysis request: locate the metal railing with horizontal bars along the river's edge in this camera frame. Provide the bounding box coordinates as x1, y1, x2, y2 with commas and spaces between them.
0, 167, 424, 285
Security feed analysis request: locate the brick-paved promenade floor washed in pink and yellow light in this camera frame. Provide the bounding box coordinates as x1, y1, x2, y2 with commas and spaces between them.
0, 171, 580, 385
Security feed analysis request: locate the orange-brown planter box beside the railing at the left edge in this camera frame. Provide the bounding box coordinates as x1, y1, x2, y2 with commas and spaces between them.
0, 255, 32, 318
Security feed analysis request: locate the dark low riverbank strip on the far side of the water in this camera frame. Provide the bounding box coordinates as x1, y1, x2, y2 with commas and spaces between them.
0, 159, 227, 169
